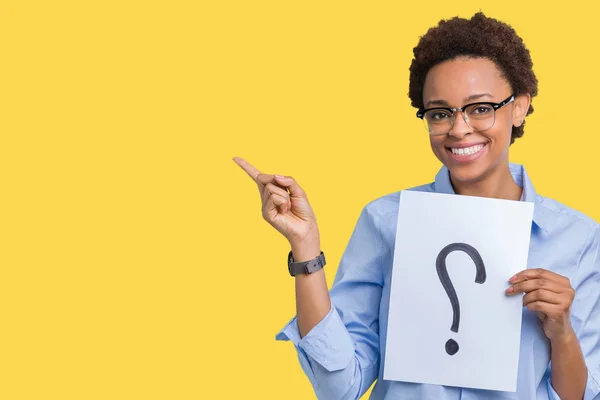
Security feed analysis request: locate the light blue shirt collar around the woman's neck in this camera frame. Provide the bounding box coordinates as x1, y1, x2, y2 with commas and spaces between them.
434, 163, 546, 231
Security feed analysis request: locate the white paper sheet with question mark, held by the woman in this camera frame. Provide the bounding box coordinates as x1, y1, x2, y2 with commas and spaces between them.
383, 191, 533, 392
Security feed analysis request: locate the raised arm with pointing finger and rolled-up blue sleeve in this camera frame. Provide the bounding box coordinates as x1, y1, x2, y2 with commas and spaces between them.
234, 161, 383, 400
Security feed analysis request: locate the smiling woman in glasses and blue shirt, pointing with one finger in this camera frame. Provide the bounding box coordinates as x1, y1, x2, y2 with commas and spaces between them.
234, 13, 600, 400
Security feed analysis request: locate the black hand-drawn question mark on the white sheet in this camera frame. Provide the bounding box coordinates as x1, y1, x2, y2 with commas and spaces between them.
435, 243, 486, 356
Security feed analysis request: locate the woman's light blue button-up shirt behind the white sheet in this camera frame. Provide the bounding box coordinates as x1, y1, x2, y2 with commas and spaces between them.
276, 163, 600, 400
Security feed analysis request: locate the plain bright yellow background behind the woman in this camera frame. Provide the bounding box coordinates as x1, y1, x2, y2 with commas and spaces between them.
0, 0, 600, 400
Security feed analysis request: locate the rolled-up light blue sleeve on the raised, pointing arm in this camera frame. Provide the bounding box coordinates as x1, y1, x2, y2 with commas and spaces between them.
276, 205, 384, 400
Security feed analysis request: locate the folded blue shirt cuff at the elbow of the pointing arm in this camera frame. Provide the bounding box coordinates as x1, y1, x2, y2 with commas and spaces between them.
275, 305, 355, 372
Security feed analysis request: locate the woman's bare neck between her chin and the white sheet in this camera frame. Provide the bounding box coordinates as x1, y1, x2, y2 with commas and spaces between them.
450, 163, 523, 200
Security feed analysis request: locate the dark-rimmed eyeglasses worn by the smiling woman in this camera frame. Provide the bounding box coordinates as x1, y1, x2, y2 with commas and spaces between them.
417, 94, 515, 135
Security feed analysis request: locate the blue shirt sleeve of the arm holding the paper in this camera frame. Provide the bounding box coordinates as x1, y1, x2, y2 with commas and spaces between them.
547, 226, 600, 400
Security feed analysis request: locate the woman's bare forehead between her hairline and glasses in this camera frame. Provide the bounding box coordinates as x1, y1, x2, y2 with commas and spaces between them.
423, 57, 510, 106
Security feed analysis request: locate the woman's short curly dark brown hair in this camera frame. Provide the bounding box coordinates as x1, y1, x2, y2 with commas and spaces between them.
408, 12, 538, 144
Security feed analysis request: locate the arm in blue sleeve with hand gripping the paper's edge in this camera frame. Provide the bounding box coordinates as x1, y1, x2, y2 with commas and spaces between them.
507, 226, 600, 400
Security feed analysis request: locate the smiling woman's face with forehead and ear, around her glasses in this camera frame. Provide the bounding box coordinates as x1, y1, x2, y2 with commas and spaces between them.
423, 57, 530, 183
